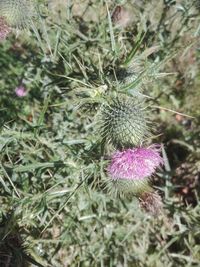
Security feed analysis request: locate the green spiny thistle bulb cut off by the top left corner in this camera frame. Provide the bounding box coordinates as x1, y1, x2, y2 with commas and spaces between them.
0, 0, 34, 29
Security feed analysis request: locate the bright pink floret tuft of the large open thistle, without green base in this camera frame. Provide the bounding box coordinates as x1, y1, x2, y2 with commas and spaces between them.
108, 145, 163, 180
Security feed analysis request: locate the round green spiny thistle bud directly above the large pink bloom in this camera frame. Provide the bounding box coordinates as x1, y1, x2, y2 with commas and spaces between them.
101, 97, 150, 148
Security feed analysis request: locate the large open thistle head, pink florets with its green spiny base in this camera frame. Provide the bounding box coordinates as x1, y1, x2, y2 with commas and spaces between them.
105, 145, 163, 195
